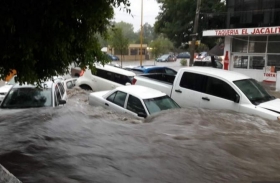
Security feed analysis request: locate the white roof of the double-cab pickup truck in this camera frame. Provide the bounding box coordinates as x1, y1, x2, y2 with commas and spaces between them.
182, 66, 250, 82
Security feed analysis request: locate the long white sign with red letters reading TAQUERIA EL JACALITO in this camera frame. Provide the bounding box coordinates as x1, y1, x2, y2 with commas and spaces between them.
203, 27, 280, 36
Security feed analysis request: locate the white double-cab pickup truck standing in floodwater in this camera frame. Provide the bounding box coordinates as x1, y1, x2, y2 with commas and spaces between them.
132, 67, 280, 121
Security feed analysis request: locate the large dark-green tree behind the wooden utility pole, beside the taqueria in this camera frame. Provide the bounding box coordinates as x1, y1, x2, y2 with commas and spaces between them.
155, 0, 226, 47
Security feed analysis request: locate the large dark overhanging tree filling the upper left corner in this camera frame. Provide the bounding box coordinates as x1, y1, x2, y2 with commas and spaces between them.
0, 0, 130, 83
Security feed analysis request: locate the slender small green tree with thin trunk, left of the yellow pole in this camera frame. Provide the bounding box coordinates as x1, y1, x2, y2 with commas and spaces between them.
110, 28, 129, 67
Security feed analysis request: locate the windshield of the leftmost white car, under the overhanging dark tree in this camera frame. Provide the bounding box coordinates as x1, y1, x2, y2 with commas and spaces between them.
1, 87, 52, 109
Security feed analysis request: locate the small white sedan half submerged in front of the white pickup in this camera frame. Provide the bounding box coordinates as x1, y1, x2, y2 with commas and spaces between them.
89, 85, 180, 118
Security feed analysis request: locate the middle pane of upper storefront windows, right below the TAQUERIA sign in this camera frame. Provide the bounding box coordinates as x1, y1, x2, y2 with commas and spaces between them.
249, 36, 267, 53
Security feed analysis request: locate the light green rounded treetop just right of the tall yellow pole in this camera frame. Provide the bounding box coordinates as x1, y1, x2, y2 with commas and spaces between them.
150, 36, 173, 57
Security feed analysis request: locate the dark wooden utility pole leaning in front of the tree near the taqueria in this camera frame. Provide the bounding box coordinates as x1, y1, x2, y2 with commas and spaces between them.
190, 0, 201, 66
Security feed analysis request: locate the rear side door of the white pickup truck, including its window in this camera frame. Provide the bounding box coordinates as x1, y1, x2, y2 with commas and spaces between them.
171, 72, 204, 107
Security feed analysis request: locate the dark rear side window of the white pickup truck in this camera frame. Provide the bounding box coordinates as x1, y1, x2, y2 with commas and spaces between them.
180, 72, 206, 92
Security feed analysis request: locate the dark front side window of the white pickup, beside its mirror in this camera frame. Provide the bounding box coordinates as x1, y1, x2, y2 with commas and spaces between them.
206, 77, 237, 101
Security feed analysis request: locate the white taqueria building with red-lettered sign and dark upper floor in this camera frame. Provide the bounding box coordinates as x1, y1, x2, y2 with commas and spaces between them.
203, 0, 280, 82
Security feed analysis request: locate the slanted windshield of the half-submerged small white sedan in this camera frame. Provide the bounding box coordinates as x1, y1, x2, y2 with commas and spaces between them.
144, 95, 180, 114
